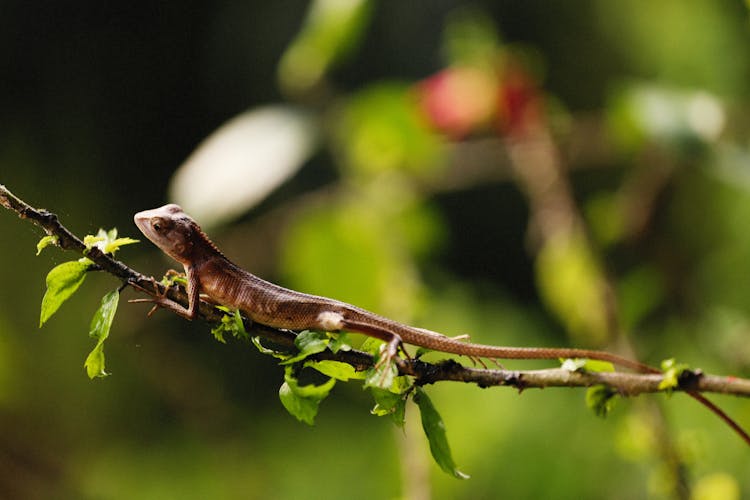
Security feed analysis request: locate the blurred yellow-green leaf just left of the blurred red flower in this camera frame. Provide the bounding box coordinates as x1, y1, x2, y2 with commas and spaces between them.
336, 83, 443, 176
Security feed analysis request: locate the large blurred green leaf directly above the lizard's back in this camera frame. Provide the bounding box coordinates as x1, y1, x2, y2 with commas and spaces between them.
281, 200, 418, 317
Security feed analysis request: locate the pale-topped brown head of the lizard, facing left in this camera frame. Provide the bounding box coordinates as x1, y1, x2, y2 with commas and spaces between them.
133, 203, 202, 265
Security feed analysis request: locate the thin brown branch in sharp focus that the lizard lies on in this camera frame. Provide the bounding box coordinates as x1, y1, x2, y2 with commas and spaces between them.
0, 184, 750, 397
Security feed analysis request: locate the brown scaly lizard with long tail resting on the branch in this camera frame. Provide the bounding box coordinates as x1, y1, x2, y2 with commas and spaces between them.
131, 204, 661, 373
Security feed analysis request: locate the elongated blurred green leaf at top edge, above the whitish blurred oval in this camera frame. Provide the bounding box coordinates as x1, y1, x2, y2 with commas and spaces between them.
279, 0, 372, 94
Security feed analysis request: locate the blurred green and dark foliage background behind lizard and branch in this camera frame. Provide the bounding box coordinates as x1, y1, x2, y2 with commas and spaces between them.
0, 0, 750, 499
